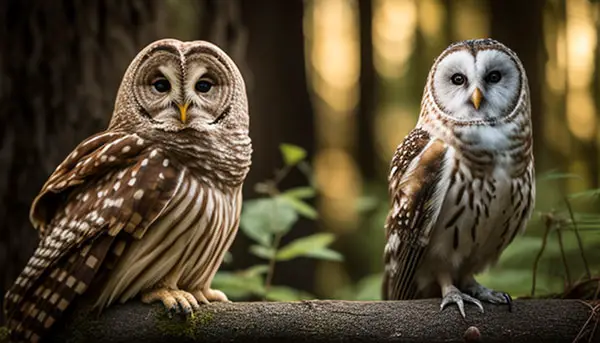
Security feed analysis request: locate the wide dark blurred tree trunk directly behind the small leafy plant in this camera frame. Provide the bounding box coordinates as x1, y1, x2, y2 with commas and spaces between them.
233, 0, 315, 291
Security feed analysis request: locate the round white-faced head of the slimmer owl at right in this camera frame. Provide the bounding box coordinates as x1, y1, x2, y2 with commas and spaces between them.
428, 39, 527, 122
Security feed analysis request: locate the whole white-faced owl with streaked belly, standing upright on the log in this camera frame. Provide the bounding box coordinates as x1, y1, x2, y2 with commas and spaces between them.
383, 39, 535, 316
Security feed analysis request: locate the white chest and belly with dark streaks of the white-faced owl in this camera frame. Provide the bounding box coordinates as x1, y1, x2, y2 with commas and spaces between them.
417, 124, 535, 289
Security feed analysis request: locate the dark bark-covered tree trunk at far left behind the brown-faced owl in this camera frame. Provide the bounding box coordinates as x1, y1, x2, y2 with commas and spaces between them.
0, 0, 165, 326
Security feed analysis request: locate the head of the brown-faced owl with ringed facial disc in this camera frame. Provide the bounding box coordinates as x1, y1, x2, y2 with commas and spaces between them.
110, 39, 249, 134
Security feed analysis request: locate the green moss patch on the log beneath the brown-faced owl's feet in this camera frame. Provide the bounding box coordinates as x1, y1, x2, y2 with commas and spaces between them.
155, 310, 213, 339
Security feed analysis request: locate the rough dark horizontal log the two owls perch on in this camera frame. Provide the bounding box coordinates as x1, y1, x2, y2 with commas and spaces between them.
34, 299, 600, 343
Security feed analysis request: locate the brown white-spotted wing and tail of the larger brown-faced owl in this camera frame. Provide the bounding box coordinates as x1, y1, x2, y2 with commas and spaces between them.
5, 132, 186, 341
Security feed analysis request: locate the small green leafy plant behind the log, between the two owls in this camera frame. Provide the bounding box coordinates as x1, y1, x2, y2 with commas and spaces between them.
213, 144, 342, 301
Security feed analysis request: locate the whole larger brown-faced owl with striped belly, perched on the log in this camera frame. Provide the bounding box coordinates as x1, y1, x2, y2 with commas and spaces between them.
5, 39, 252, 342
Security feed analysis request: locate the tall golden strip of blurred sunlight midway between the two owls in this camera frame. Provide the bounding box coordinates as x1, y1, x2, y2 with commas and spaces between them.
305, 0, 361, 236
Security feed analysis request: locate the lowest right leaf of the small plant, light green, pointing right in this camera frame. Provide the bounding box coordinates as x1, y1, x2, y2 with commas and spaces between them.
276, 233, 341, 261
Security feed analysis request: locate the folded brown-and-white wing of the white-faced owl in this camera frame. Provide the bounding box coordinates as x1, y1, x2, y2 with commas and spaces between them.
383, 128, 448, 300
